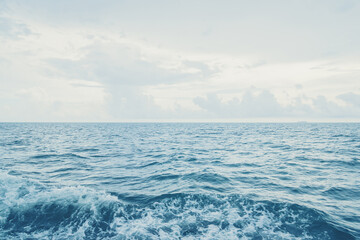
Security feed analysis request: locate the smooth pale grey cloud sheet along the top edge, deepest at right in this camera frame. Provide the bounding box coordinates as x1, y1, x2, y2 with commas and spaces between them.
8, 0, 360, 61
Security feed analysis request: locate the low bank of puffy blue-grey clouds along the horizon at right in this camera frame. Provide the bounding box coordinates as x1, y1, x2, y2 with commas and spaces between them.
194, 89, 360, 119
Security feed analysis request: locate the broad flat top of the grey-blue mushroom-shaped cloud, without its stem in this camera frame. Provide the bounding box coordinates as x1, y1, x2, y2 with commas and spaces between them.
46, 39, 215, 86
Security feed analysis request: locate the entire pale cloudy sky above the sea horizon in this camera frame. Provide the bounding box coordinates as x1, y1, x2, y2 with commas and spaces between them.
0, 0, 360, 122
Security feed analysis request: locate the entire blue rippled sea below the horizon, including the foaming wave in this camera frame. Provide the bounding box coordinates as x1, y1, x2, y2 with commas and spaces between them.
0, 123, 360, 240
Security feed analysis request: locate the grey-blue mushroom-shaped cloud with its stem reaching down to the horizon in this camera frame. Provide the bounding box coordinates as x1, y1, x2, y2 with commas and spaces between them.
44, 39, 215, 120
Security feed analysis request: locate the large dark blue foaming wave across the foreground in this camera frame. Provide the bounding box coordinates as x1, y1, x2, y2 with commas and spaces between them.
0, 174, 355, 239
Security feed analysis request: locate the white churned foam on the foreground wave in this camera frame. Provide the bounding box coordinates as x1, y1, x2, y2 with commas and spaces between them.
0, 174, 334, 239
